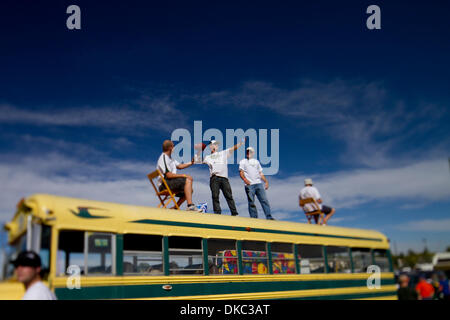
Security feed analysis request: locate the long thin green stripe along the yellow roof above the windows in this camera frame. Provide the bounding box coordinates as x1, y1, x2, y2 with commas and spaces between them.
129, 219, 383, 242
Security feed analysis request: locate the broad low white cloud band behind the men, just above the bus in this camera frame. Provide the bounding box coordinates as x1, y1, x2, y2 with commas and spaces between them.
0, 153, 450, 225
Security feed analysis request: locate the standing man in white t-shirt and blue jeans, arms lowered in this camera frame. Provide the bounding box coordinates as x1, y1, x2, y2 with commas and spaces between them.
239, 147, 275, 220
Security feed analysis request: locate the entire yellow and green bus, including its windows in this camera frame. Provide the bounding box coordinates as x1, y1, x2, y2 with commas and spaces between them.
0, 194, 396, 299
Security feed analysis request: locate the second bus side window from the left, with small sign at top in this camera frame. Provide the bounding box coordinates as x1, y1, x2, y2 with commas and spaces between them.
87, 232, 114, 275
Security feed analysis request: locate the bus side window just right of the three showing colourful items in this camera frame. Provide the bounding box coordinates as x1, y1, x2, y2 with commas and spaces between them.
297, 244, 325, 273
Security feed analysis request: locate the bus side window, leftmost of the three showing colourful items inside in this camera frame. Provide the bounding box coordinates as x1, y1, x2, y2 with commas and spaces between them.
208, 239, 238, 275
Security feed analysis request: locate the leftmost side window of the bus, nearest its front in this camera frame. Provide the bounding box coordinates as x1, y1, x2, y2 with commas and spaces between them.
57, 230, 84, 276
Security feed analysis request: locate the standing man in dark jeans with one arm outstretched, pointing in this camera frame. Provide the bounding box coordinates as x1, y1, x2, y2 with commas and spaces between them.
196, 140, 244, 216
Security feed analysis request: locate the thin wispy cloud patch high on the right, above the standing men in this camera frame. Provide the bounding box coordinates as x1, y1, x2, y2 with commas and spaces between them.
195, 79, 450, 168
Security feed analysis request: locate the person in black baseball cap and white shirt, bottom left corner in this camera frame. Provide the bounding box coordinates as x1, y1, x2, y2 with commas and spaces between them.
11, 251, 56, 300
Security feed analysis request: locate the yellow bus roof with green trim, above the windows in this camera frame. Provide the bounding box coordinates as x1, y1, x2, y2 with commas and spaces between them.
6, 194, 389, 249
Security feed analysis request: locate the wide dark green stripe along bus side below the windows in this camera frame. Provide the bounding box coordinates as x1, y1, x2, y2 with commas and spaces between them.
55, 279, 394, 300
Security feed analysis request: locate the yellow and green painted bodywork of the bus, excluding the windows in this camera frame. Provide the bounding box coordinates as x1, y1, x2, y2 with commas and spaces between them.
0, 194, 396, 299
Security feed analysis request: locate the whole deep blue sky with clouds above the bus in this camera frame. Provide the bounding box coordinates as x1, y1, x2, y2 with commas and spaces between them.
0, 1, 450, 255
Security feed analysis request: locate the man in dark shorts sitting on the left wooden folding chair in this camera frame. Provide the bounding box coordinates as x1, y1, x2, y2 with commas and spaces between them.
156, 140, 197, 211
